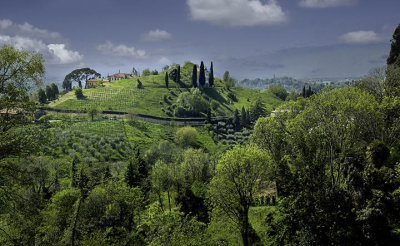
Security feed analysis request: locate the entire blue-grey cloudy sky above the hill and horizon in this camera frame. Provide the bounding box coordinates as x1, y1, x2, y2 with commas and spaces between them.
0, 0, 400, 84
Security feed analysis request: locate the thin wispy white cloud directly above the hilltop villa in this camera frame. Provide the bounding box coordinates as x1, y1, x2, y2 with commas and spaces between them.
97, 41, 147, 58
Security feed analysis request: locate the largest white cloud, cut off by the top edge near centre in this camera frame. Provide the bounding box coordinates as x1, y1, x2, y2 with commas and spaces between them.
187, 0, 287, 27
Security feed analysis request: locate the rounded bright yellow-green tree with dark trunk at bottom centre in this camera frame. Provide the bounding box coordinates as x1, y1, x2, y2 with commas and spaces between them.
209, 147, 269, 245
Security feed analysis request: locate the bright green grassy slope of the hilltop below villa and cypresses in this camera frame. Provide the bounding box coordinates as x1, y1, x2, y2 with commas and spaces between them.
49, 63, 281, 117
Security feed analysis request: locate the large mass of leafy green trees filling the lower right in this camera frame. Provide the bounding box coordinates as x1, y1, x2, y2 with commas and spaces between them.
253, 87, 400, 245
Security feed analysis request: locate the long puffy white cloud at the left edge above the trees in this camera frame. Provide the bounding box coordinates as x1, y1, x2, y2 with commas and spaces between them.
0, 35, 83, 65
